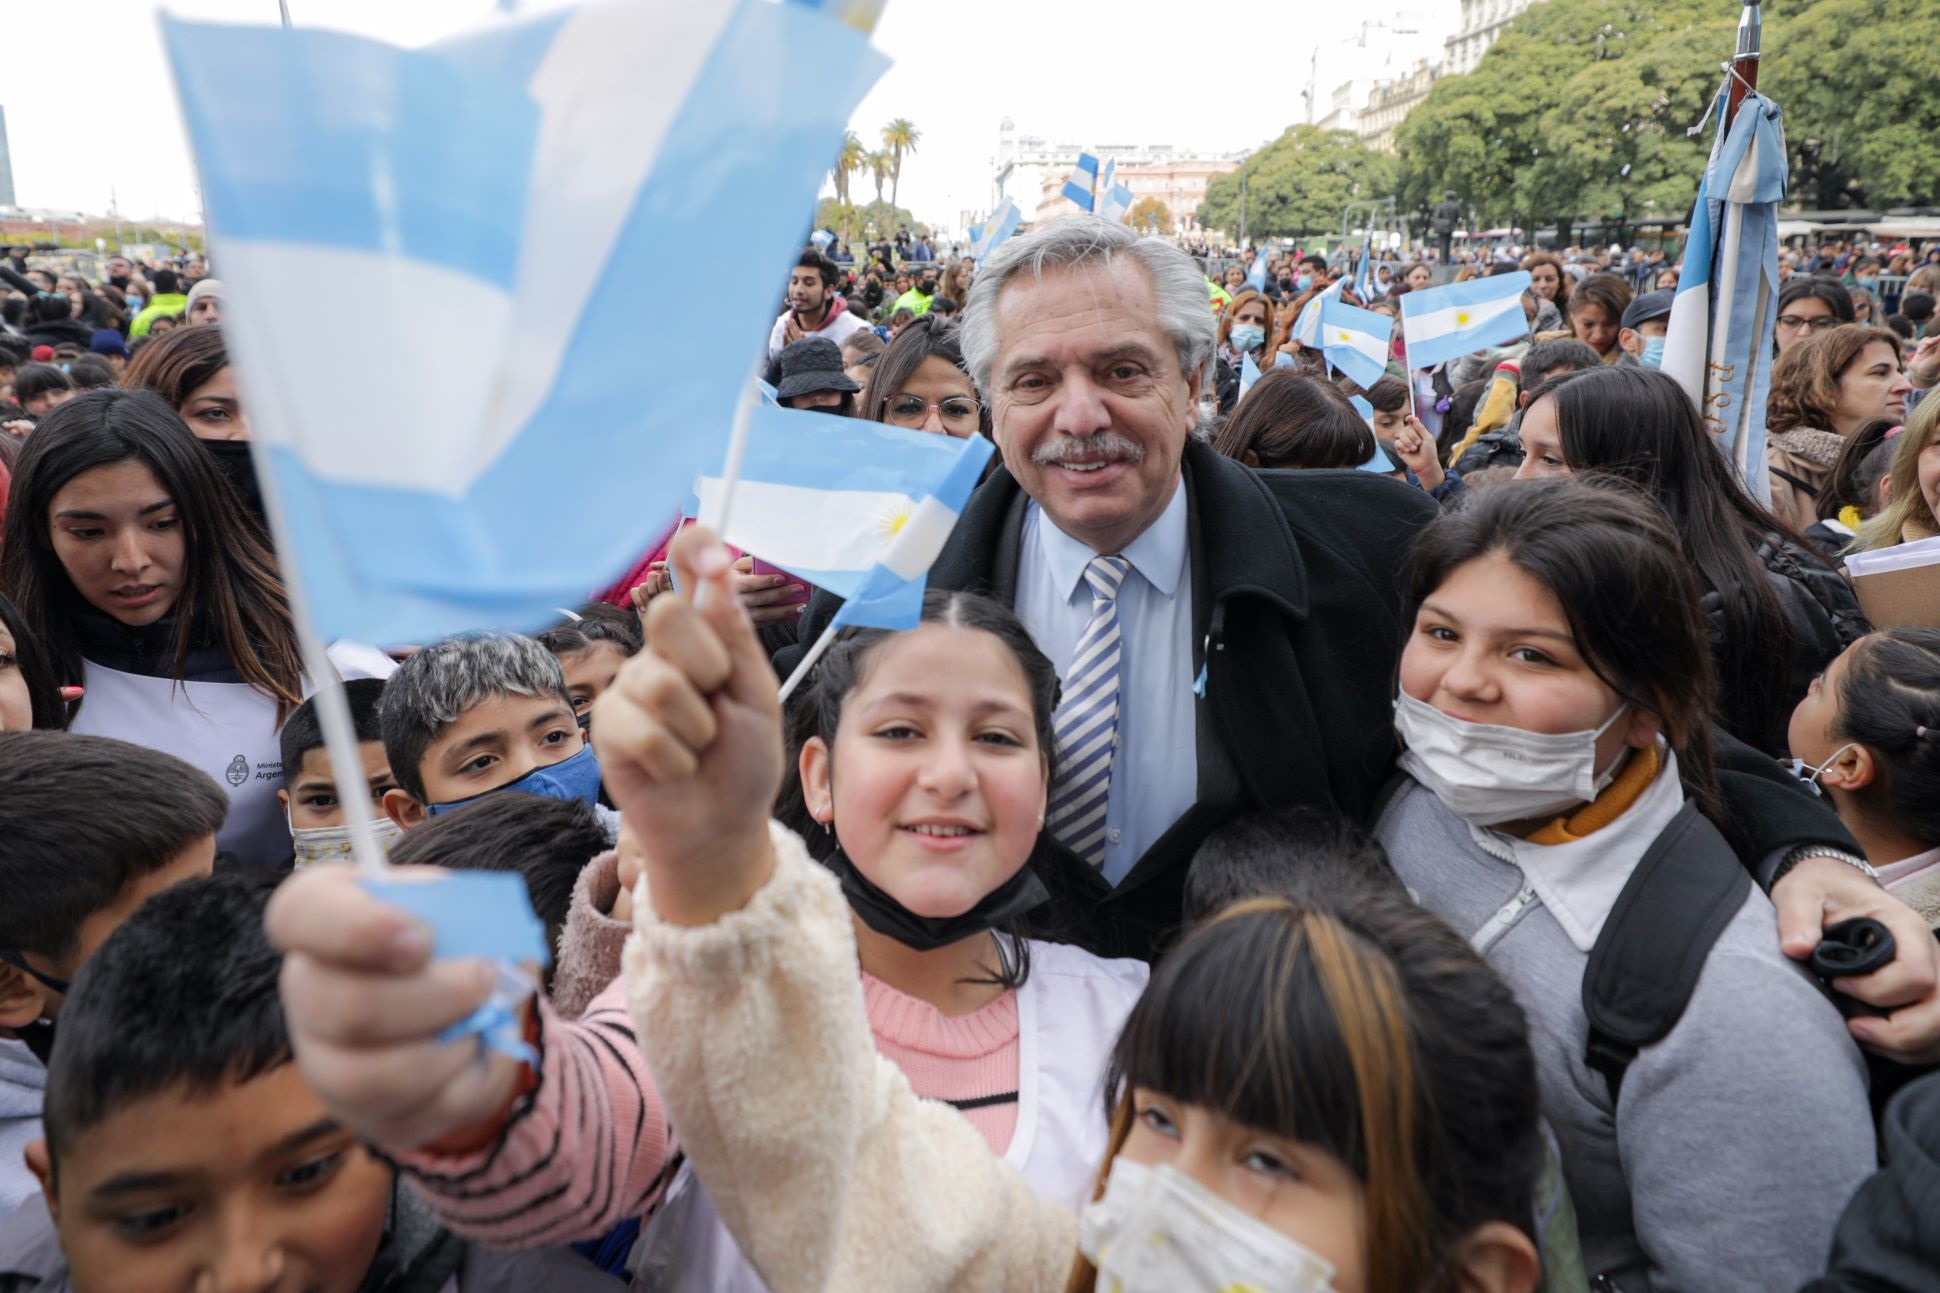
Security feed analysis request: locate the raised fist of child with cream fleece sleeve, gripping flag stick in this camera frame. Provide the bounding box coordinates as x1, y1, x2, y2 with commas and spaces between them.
594, 526, 782, 924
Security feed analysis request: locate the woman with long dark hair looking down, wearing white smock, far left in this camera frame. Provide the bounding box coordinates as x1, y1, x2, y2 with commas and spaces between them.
0, 390, 386, 866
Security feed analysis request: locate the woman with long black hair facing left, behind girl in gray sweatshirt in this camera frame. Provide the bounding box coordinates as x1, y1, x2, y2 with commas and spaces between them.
1517, 357, 1866, 755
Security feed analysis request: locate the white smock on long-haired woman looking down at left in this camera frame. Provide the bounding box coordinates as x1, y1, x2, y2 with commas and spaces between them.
68, 643, 396, 866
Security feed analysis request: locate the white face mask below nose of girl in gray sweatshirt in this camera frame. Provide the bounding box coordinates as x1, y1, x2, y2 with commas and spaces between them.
1395, 691, 1630, 827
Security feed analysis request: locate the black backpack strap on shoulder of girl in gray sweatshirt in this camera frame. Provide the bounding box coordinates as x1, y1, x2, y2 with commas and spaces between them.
1583, 804, 1752, 1105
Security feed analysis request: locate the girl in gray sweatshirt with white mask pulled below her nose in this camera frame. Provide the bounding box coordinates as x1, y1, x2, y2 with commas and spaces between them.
1375, 477, 1874, 1293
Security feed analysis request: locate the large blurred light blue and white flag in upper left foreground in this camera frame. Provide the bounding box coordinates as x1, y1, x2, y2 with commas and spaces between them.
163, 0, 885, 645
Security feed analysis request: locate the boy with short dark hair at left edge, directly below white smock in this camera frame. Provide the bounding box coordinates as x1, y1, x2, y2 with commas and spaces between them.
0, 732, 229, 1217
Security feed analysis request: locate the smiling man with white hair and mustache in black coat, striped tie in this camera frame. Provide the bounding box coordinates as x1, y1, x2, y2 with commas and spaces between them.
776, 216, 1940, 1009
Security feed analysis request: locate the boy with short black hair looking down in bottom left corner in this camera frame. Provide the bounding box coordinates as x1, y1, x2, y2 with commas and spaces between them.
0, 874, 615, 1293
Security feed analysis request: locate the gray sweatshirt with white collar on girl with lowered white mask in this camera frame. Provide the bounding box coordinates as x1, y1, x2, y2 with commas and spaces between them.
1375, 755, 1874, 1293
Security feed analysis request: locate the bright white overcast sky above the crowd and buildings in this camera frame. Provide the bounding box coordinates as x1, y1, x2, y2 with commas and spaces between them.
0, 0, 1459, 223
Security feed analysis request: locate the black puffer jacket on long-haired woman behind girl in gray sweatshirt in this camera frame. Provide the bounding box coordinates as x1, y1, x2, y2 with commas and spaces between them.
1703, 534, 1872, 755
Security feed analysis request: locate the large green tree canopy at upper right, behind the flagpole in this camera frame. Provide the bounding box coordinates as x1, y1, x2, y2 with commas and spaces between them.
1395, 0, 1940, 229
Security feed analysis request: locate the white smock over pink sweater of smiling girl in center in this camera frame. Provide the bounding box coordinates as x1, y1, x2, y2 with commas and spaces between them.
632, 940, 1150, 1293
